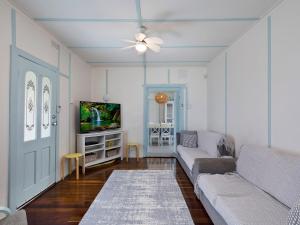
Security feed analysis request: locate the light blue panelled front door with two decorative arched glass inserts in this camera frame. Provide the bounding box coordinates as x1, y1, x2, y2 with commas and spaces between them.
11, 52, 57, 207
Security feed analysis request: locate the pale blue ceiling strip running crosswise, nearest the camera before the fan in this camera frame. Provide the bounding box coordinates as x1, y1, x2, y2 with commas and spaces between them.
34, 17, 260, 23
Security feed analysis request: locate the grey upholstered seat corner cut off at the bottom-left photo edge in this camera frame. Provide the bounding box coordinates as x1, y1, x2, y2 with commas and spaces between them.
0, 207, 27, 225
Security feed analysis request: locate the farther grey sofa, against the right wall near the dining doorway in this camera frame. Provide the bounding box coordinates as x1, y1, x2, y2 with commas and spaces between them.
177, 130, 234, 183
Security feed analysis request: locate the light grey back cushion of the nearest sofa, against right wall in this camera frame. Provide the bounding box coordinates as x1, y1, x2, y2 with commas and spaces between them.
237, 145, 300, 208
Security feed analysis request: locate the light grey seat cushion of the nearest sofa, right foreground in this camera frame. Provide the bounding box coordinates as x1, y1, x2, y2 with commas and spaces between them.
197, 174, 289, 225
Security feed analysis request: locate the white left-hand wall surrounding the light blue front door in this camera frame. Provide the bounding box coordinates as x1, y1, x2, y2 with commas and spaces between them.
0, 0, 91, 206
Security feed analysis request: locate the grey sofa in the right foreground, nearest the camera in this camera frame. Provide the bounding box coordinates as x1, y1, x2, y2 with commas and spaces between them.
195, 145, 300, 225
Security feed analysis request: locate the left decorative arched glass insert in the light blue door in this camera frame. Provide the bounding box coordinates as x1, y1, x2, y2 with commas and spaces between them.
24, 71, 37, 141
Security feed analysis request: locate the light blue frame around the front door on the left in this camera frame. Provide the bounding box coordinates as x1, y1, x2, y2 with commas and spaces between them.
8, 45, 60, 212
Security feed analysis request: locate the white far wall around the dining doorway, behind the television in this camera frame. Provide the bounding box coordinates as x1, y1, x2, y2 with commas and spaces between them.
91, 66, 207, 157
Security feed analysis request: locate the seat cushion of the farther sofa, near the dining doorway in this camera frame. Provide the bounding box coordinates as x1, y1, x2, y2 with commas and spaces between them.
177, 145, 211, 171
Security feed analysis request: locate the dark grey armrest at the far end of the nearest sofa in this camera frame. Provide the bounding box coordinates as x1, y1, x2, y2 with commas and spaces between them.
192, 158, 236, 180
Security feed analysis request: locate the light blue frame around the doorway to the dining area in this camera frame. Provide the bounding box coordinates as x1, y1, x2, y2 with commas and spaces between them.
143, 84, 188, 157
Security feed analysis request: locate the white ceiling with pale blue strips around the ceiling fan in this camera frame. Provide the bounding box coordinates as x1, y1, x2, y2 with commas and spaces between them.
11, 0, 281, 65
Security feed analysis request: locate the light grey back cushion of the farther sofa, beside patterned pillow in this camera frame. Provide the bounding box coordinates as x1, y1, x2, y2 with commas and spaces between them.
198, 130, 223, 157
